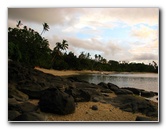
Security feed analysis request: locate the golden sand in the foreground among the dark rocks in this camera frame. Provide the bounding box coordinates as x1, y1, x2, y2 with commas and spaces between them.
29, 96, 153, 122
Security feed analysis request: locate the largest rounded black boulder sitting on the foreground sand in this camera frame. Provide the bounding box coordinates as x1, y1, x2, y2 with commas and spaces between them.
39, 88, 75, 115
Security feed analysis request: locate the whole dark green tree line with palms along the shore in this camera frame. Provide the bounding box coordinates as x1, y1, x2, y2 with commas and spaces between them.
8, 21, 158, 73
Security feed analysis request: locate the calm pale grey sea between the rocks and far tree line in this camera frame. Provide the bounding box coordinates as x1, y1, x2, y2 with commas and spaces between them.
71, 73, 159, 92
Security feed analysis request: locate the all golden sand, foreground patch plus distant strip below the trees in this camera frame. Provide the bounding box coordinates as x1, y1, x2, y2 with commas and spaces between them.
30, 68, 157, 122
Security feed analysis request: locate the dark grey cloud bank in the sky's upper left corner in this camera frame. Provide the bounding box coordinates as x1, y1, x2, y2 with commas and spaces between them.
8, 8, 84, 25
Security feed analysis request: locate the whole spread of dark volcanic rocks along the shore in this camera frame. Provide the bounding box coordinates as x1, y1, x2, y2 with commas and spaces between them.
8, 61, 158, 121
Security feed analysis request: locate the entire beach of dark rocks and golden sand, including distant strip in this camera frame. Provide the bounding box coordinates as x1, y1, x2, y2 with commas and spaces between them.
8, 62, 158, 122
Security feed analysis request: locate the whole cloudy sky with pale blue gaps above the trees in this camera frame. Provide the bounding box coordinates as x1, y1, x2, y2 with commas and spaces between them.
8, 8, 159, 63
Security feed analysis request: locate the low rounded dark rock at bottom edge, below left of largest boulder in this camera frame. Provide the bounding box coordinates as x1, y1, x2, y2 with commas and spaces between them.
13, 112, 45, 121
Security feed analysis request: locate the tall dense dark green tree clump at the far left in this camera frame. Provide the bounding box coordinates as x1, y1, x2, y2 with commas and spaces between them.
8, 26, 51, 67
